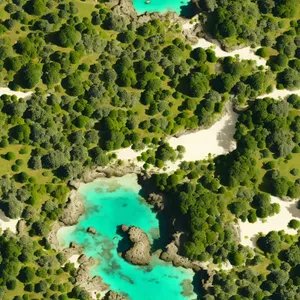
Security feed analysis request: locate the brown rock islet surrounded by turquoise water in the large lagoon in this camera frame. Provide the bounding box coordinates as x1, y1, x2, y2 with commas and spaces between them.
122, 226, 151, 266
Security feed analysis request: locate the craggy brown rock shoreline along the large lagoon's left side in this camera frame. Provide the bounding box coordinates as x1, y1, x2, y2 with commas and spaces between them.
47, 165, 144, 300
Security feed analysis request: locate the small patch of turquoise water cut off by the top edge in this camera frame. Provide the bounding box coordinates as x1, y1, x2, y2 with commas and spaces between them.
133, 0, 189, 15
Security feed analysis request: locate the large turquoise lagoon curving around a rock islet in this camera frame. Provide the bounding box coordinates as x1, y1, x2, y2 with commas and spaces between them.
59, 174, 196, 300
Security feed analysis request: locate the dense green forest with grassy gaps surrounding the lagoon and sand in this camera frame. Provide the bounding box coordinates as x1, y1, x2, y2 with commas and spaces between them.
0, 0, 300, 300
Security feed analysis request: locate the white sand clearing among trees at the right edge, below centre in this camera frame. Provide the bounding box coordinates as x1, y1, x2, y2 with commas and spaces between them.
239, 196, 300, 247
